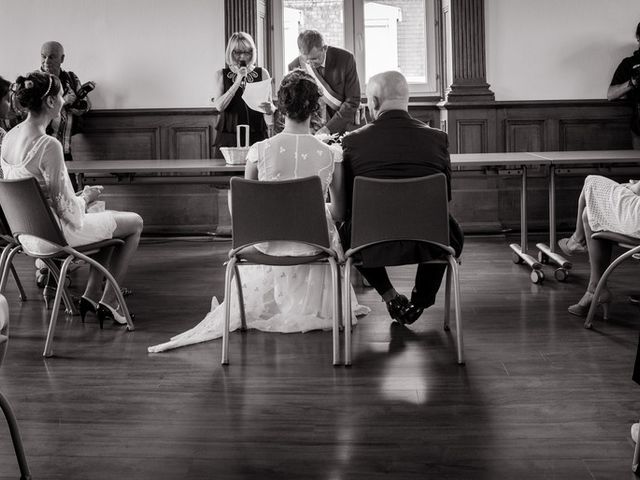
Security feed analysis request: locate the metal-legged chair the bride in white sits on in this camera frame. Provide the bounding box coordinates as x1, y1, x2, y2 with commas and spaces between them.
222, 176, 340, 365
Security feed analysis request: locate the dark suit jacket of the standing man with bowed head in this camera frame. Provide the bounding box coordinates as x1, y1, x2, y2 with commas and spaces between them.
289, 47, 360, 133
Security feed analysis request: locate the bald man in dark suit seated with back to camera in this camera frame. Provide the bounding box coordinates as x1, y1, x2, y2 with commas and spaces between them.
341, 71, 464, 324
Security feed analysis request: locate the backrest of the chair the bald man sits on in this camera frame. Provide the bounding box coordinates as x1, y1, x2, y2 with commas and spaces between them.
351, 173, 449, 249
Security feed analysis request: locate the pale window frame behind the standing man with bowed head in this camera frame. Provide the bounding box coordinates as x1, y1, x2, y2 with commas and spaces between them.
271, 0, 443, 100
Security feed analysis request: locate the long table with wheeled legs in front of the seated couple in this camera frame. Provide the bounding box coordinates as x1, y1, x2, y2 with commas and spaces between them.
67, 150, 640, 283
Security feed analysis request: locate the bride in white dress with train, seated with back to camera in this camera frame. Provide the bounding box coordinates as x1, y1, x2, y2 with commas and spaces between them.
148, 70, 370, 353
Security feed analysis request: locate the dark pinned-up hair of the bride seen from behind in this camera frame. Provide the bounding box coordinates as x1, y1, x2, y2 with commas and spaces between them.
277, 69, 322, 122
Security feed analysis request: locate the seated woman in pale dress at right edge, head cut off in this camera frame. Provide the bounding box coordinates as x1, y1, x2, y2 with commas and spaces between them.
558, 175, 640, 317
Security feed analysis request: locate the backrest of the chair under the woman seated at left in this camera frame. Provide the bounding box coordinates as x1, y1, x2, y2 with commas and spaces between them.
0, 177, 67, 247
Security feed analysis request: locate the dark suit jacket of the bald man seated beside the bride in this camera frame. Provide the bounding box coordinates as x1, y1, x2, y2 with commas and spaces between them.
341, 110, 464, 267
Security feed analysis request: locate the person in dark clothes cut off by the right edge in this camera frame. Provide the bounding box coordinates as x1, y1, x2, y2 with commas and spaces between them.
607, 23, 640, 150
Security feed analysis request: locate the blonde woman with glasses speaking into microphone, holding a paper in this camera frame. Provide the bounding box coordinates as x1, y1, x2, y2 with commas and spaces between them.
213, 32, 275, 157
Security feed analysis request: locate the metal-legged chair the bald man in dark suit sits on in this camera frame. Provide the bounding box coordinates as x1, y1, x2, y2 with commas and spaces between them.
342, 173, 464, 365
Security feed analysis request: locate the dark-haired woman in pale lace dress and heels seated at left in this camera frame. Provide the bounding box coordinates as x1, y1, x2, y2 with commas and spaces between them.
0, 72, 142, 324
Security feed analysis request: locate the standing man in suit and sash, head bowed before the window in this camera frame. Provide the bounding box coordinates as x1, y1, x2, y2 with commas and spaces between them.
289, 30, 360, 134
